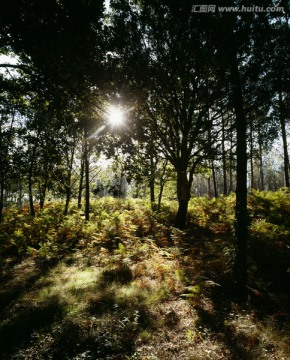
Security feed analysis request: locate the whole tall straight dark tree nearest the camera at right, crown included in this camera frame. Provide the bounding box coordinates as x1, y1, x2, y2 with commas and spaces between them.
213, 1, 286, 298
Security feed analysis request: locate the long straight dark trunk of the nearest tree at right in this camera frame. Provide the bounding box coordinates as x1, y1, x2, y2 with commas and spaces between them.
231, 54, 248, 299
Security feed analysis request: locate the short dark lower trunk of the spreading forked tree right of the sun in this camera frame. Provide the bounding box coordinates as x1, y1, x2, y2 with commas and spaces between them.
175, 171, 192, 229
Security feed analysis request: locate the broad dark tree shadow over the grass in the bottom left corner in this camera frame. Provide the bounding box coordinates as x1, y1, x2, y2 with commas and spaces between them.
0, 264, 151, 360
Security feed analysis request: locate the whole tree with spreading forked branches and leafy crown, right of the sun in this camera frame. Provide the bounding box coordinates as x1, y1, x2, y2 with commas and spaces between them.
112, 0, 222, 228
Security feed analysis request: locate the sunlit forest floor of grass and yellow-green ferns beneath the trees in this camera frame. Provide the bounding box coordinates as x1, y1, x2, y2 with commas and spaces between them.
0, 191, 290, 360
